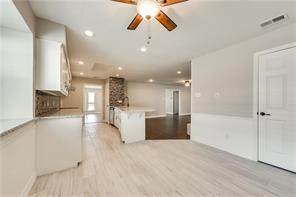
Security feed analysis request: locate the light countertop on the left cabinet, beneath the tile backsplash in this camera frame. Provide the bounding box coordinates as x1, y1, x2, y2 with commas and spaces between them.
39, 109, 83, 119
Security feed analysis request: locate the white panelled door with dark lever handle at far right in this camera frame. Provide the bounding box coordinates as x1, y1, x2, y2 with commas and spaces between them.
258, 47, 296, 172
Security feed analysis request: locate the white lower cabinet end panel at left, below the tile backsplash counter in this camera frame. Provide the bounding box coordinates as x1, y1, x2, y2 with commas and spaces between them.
36, 118, 82, 176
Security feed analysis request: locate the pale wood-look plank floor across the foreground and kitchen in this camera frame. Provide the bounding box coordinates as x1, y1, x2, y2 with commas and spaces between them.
30, 123, 296, 197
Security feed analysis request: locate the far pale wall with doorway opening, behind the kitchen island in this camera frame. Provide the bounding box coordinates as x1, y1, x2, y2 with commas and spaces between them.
127, 82, 190, 116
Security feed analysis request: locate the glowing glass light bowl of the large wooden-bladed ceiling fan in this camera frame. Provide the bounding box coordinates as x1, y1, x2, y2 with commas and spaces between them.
137, 0, 160, 21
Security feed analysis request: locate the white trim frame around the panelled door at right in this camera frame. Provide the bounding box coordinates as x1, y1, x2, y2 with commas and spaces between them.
253, 42, 296, 161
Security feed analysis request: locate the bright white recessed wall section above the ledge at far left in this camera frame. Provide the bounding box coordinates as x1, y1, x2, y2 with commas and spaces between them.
0, 28, 34, 119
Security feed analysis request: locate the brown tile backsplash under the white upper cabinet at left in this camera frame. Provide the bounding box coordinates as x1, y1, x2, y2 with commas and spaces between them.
35, 90, 60, 116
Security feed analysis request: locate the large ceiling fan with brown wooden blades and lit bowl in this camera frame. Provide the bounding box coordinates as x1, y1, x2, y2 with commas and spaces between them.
111, 0, 188, 31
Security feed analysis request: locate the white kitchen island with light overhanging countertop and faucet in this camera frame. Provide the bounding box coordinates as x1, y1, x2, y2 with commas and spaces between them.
114, 107, 155, 143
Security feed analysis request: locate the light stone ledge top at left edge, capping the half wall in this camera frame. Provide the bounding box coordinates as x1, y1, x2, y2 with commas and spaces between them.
0, 118, 36, 137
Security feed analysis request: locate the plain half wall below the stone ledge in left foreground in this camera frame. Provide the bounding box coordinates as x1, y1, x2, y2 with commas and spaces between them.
0, 122, 36, 196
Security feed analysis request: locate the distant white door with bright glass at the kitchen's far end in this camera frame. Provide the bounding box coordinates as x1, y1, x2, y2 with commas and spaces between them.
83, 85, 103, 124
